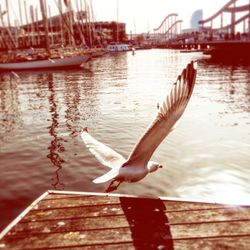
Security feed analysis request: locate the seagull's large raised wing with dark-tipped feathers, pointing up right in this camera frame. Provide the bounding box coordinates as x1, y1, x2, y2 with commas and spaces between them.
124, 62, 196, 166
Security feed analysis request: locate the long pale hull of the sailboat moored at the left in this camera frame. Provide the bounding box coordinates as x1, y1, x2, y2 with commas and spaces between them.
0, 55, 91, 70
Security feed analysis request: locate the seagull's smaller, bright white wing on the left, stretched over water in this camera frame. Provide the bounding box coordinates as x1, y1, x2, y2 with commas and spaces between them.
81, 128, 126, 168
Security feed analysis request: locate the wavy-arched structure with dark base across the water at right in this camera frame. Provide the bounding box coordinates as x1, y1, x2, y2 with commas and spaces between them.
154, 0, 250, 57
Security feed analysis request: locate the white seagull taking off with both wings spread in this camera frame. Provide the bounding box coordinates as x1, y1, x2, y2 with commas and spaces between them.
81, 61, 197, 192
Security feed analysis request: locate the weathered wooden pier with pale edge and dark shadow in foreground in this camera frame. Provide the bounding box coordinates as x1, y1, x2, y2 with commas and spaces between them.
0, 191, 250, 250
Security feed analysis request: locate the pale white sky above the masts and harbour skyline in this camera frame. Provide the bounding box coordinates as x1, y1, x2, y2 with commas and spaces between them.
0, 0, 238, 33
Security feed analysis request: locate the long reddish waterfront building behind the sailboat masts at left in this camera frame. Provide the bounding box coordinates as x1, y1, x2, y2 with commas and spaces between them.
0, 11, 127, 51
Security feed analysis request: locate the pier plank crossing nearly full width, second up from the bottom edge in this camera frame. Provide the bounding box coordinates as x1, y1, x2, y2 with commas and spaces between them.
4, 222, 250, 249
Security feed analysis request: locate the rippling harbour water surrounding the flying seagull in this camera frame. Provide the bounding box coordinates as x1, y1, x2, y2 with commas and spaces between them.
0, 50, 250, 231
